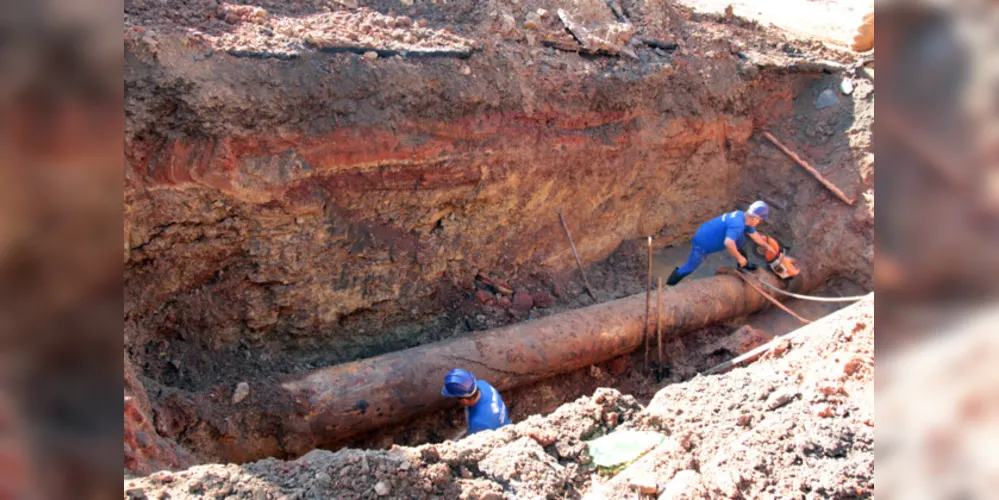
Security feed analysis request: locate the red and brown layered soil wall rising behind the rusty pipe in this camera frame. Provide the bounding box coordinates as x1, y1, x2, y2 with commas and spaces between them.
123, 0, 873, 473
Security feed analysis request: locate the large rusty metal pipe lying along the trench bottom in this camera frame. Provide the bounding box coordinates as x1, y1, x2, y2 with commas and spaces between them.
180, 260, 823, 462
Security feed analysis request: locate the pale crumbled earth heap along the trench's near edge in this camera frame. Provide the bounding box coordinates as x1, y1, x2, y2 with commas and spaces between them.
125, 295, 874, 499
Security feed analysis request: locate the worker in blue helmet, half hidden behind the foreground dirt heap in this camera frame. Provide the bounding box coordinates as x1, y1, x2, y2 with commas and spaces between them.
441, 368, 510, 434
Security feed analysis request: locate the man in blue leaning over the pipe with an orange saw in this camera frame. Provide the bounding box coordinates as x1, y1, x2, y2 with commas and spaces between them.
666, 201, 770, 285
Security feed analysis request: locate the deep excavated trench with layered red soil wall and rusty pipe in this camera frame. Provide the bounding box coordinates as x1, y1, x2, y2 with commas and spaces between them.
123, 1, 873, 474
